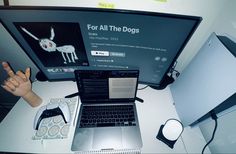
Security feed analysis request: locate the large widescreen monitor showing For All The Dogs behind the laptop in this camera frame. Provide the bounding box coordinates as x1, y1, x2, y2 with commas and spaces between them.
0, 7, 201, 87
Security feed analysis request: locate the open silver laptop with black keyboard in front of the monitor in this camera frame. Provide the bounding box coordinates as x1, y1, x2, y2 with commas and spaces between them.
71, 70, 142, 151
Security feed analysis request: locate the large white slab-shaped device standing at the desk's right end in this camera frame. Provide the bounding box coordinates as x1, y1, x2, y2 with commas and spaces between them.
170, 33, 236, 126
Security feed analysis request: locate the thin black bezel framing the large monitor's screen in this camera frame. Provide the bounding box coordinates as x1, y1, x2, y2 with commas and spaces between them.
0, 6, 202, 88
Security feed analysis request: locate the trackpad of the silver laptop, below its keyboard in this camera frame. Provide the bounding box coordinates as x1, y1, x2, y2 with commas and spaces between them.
93, 127, 122, 150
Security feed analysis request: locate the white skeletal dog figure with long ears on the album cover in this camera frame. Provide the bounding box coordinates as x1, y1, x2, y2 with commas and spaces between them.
21, 27, 78, 64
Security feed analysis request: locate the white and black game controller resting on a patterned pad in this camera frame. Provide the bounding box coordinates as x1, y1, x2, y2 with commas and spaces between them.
34, 102, 70, 130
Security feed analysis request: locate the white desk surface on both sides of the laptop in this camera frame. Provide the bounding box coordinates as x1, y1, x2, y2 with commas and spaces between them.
0, 81, 209, 153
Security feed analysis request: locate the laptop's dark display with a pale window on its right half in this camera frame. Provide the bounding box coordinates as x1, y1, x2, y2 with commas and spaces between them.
75, 70, 139, 103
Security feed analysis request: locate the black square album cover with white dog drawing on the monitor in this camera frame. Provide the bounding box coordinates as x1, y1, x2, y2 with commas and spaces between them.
14, 22, 88, 67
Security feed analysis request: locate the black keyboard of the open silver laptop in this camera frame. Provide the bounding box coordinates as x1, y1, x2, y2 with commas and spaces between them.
79, 105, 136, 128
